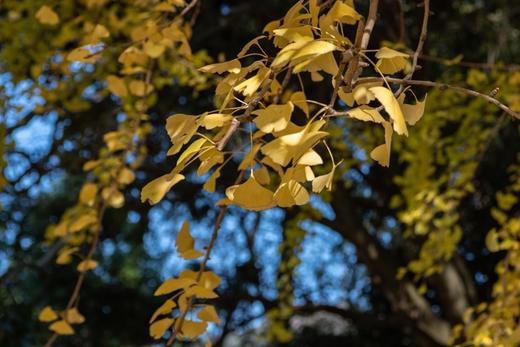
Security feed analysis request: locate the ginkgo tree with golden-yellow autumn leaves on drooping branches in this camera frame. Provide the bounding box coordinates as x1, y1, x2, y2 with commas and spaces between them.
1, 0, 520, 346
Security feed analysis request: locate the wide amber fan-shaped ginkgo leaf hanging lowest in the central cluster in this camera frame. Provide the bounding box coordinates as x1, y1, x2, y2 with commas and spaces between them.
226, 176, 274, 211
